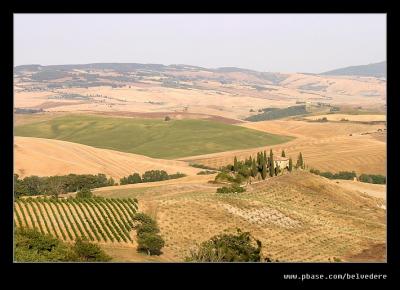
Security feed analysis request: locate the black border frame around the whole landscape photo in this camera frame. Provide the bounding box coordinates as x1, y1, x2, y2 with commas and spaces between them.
0, 0, 400, 288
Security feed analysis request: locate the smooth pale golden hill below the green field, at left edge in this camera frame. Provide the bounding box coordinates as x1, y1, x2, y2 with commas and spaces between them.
14, 137, 199, 181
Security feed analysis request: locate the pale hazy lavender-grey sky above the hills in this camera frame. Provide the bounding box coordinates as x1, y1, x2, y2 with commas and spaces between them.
14, 14, 386, 73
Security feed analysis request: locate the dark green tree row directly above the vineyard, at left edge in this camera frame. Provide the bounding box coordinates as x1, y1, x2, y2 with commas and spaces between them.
14, 173, 115, 197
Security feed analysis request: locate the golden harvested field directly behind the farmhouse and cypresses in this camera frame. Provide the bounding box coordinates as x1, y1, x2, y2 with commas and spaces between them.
180, 120, 386, 175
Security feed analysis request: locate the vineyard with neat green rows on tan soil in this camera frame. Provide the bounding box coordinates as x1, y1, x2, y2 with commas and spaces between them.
14, 198, 138, 243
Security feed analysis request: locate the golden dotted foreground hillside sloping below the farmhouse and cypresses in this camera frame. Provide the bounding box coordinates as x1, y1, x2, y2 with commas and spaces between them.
95, 171, 386, 262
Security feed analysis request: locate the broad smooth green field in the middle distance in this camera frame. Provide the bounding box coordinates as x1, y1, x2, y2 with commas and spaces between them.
14, 115, 293, 159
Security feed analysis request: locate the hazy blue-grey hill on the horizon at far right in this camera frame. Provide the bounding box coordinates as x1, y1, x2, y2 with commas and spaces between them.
321, 61, 386, 78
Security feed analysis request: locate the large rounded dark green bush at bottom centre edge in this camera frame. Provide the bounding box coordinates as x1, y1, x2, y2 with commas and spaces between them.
185, 229, 262, 262
